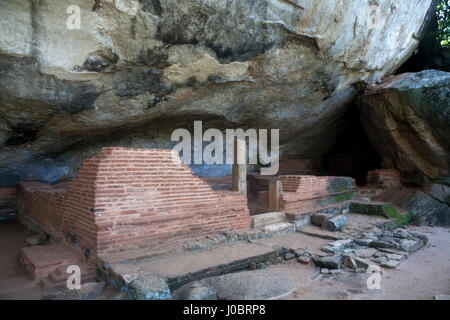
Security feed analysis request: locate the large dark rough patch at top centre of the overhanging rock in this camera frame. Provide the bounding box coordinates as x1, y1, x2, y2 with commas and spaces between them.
156, 6, 280, 63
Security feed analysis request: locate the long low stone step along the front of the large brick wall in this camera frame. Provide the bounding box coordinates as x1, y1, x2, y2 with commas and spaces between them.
101, 241, 282, 290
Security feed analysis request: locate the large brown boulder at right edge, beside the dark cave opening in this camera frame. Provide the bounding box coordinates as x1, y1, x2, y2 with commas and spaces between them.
360, 70, 450, 186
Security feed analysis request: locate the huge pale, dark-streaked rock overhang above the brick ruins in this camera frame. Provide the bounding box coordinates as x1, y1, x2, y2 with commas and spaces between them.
0, 0, 433, 186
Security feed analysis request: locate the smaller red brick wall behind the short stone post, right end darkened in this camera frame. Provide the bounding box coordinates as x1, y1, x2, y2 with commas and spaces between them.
257, 175, 355, 214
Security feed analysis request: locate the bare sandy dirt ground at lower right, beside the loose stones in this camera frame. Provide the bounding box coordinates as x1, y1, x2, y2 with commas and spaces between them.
279, 227, 450, 300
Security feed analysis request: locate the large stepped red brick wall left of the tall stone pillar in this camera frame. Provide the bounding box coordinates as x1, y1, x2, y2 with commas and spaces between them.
18, 148, 251, 257
